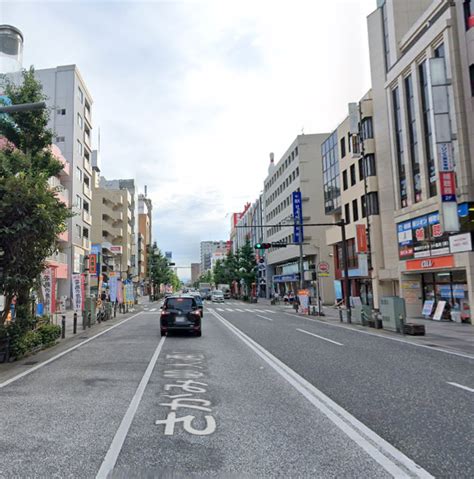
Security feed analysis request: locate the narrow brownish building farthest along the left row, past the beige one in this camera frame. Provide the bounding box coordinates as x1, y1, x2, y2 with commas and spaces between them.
137, 191, 153, 294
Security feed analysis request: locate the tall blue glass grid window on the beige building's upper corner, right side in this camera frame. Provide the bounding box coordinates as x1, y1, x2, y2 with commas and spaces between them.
321, 132, 341, 215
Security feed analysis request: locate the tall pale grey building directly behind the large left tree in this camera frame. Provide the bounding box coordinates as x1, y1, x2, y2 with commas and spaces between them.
35, 65, 92, 298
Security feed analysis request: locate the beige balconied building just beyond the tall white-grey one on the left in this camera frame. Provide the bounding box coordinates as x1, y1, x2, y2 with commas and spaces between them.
92, 166, 134, 279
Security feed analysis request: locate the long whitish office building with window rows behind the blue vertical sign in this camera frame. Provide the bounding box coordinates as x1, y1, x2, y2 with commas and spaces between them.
262, 133, 334, 303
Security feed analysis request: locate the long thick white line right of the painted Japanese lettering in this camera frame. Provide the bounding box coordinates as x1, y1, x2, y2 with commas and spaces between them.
213, 313, 433, 479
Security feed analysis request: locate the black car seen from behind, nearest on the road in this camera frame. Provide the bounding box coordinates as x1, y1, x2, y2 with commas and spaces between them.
160, 295, 202, 336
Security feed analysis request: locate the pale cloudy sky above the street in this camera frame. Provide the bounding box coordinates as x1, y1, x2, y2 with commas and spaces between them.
0, 0, 376, 279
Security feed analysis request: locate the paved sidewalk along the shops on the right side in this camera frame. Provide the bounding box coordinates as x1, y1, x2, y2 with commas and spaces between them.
257, 298, 474, 356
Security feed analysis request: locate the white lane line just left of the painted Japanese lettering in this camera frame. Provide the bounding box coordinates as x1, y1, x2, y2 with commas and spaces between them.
96, 337, 166, 479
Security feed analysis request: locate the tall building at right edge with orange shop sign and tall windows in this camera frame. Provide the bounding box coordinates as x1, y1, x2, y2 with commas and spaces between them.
368, 0, 474, 322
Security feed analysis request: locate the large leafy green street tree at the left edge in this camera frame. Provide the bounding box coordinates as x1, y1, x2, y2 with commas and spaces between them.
0, 69, 71, 324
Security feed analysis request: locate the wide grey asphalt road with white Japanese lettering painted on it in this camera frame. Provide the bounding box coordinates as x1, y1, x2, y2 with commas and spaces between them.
0, 304, 474, 478
